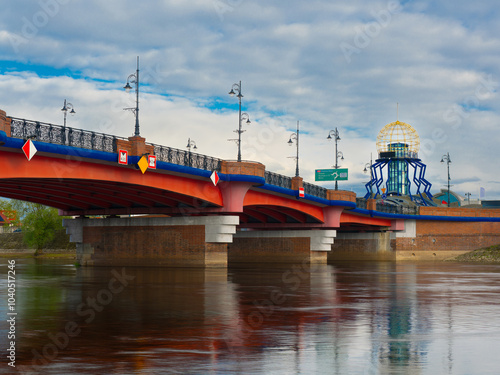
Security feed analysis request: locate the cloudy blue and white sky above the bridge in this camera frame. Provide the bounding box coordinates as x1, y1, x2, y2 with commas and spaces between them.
0, 0, 500, 199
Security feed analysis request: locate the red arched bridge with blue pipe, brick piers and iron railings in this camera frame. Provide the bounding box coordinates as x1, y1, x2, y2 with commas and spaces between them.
0, 111, 500, 266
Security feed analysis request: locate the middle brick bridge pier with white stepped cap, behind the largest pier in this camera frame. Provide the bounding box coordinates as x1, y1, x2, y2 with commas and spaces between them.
228, 230, 336, 264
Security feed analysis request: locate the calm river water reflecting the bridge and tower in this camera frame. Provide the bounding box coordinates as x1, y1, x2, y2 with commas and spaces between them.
0, 259, 500, 375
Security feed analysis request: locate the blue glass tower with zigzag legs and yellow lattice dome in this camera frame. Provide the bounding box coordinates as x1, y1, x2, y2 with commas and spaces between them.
365, 121, 434, 206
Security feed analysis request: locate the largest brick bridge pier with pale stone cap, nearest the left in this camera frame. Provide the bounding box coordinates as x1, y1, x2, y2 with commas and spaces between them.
64, 216, 239, 267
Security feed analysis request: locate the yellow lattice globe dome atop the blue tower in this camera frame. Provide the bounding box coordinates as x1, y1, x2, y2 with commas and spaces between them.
377, 121, 420, 158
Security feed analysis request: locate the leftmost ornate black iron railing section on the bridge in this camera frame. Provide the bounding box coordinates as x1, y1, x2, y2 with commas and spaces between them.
10, 117, 126, 152
